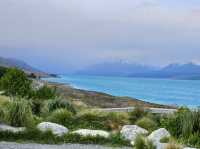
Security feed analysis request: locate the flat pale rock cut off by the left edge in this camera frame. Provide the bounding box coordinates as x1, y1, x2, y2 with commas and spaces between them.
0, 124, 26, 133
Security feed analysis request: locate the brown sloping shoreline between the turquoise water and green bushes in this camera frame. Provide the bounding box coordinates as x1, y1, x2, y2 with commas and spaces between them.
44, 80, 177, 109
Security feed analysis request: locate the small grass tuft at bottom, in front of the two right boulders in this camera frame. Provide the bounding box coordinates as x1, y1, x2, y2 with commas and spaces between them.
134, 135, 156, 149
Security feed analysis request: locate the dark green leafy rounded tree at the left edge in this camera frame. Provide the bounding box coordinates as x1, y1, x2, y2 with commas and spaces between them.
0, 68, 31, 97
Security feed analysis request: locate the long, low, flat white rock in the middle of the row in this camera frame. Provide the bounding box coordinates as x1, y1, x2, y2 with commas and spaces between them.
72, 129, 110, 138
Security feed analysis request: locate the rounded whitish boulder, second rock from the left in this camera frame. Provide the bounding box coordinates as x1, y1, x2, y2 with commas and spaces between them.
37, 122, 69, 136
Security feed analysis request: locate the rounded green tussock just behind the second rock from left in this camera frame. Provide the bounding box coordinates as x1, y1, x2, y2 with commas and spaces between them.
47, 109, 73, 127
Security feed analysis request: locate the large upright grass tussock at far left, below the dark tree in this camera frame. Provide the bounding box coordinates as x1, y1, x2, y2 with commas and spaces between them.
5, 99, 34, 127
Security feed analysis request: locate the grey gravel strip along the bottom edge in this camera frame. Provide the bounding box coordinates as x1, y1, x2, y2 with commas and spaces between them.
0, 142, 131, 149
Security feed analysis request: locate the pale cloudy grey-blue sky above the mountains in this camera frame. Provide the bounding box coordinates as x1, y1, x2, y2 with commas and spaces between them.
0, 0, 200, 73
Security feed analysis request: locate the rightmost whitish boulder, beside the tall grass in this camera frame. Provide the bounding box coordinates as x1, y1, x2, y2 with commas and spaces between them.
148, 128, 171, 143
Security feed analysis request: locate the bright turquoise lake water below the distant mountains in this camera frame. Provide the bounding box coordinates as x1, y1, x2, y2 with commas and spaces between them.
45, 75, 200, 107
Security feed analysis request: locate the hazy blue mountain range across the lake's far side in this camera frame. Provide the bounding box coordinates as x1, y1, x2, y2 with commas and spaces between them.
76, 62, 200, 79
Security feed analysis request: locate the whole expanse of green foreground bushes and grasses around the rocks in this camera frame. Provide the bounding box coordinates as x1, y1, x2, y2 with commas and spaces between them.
0, 68, 200, 149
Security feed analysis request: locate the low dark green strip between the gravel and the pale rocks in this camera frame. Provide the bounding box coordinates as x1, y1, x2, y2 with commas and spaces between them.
0, 128, 130, 147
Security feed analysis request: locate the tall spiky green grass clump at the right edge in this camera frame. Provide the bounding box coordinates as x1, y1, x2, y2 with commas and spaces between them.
161, 108, 200, 147
